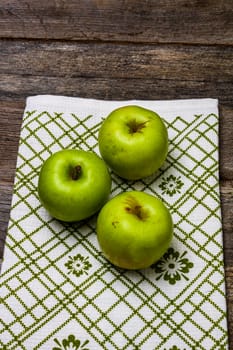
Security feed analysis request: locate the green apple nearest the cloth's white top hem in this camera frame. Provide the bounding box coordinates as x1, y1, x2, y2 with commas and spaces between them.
98, 105, 168, 180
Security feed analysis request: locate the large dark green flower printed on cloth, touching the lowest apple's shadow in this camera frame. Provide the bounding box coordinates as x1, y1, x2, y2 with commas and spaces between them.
152, 248, 193, 285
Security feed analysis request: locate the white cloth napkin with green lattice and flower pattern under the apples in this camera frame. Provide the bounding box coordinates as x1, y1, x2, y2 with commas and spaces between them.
0, 95, 228, 350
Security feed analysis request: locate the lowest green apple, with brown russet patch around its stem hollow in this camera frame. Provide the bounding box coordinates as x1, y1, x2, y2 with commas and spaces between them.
97, 191, 173, 270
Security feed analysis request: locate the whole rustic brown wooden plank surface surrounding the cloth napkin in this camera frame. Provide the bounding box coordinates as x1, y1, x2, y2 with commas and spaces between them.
0, 0, 233, 349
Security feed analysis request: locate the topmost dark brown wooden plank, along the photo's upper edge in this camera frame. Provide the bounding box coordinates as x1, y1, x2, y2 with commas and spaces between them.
0, 0, 233, 44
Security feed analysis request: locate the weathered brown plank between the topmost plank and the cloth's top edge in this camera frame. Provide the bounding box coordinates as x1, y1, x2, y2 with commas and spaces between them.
0, 40, 233, 110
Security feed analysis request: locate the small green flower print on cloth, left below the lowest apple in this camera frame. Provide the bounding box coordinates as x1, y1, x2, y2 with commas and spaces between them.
65, 254, 92, 277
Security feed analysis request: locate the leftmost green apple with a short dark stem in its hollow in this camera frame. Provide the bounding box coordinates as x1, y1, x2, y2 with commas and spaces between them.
38, 149, 111, 222
